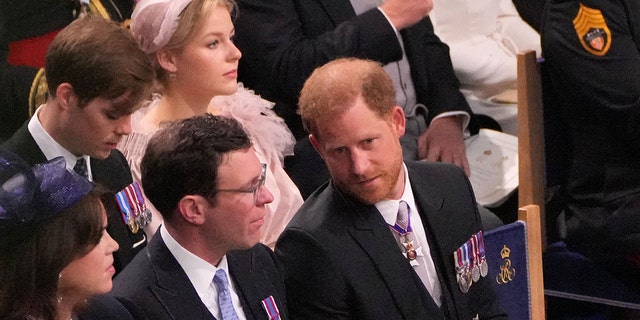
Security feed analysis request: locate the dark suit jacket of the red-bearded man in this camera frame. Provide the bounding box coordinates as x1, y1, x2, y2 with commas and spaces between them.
276, 162, 506, 320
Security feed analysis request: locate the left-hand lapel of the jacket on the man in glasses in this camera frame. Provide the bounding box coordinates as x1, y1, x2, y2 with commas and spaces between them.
145, 232, 215, 320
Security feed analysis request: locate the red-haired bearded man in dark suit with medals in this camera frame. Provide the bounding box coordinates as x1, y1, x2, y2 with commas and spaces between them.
276, 58, 506, 320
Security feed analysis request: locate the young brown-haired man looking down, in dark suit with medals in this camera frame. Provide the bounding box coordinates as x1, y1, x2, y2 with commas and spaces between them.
3, 16, 154, 271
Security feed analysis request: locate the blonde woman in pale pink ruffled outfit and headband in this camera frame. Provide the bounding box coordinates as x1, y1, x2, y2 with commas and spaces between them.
118, 0, 302, 247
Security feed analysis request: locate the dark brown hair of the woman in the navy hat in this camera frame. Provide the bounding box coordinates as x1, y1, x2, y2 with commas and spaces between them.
0, 189, 104, 320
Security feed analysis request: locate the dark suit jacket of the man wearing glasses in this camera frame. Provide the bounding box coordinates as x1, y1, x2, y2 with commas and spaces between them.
112, 232, 288, 320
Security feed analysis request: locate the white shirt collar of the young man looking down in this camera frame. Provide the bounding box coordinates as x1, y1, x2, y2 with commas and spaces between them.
27, 106, 93, 181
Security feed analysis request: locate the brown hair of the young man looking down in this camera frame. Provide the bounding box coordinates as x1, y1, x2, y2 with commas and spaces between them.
45, 15, 155, 108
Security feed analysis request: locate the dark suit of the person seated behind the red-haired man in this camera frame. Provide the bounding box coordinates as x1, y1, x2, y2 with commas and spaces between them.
234, 0, 475, 196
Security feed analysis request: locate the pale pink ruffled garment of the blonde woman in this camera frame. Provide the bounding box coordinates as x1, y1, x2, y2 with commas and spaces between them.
118, 83, 303, 248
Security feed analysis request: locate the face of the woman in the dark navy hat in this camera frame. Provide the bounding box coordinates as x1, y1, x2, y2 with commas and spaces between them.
58, 208, 118, 303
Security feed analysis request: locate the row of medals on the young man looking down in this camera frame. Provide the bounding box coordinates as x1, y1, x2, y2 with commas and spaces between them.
116, 181, 151, 233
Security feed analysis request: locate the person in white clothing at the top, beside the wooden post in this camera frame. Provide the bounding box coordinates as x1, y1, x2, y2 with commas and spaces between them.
430, 0, 540, 135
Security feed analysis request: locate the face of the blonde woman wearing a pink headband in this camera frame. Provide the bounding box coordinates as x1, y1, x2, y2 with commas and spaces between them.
158, 5, 242, 102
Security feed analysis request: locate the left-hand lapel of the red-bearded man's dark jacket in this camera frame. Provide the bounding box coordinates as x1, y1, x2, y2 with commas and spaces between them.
335, 191, 439, 319
